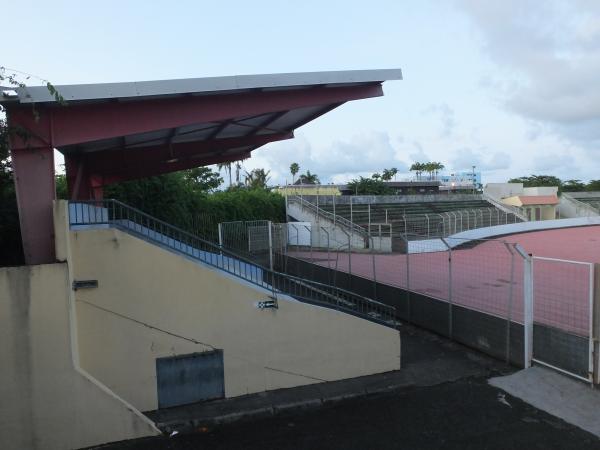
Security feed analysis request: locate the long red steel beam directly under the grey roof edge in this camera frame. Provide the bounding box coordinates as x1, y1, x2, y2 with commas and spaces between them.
8, 84, 383, 150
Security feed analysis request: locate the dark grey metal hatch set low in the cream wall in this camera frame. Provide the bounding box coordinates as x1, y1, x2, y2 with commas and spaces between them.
156, 350, 225, 408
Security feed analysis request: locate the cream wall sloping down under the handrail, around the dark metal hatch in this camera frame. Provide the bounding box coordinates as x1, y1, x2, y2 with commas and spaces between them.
70, 229, 400, 411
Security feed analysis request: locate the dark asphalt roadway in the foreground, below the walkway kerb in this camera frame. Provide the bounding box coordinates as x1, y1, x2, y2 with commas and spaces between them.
92, 377, 600, 450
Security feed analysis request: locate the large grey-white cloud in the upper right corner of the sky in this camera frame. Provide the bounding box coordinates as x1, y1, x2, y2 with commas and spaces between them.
458, 0, 600, 149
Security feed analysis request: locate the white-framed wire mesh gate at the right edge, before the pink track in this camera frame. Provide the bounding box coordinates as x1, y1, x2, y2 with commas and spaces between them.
532, 256, 594, 382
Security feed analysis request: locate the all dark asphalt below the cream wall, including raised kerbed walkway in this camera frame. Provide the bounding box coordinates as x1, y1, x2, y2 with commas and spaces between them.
85, 326, 600, 450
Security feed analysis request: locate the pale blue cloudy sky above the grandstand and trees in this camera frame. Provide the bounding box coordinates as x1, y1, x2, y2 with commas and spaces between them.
0, 0, 600, 184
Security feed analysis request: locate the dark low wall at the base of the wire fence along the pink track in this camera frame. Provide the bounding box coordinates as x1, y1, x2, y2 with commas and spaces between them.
287, 258, 600, 378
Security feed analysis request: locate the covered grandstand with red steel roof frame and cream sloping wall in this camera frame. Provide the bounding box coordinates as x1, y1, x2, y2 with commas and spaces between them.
0, 69, 402, 450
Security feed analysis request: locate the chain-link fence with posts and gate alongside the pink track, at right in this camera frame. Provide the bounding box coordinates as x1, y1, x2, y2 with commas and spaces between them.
286, 222, 593, 379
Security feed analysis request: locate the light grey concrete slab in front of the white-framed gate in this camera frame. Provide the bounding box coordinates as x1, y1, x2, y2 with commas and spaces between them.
490, 367, 600, 437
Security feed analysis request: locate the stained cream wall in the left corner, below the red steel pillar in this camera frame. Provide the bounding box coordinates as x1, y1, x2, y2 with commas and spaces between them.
0, 264, 158, 450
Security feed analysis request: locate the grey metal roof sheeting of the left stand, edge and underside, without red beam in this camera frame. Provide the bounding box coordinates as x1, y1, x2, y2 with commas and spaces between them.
37, 69, 402, 157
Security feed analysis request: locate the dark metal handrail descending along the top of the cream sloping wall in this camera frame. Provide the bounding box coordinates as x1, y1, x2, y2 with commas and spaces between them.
69, 199, 396, 328
